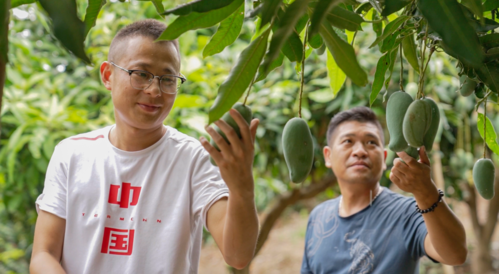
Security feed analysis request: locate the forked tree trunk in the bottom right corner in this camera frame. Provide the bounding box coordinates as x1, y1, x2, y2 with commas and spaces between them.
464, 169, 499, 274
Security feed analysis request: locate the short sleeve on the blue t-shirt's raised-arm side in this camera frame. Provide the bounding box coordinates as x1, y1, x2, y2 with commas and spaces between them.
402, 199, 438, 263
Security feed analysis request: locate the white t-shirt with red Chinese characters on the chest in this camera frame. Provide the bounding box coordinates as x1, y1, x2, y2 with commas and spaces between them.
36, 126, 229, 274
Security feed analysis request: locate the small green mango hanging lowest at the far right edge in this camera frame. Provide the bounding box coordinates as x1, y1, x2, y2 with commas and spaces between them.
473, 158, 495, 200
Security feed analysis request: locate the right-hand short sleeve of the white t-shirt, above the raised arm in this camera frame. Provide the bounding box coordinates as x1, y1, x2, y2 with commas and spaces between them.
191, 146, 229, 230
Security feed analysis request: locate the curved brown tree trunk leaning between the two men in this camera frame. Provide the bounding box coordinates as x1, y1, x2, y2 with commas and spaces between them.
229, 175, 336, 274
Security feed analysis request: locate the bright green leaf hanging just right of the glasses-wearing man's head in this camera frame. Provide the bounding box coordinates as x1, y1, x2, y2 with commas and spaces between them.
203, 4, 244, 58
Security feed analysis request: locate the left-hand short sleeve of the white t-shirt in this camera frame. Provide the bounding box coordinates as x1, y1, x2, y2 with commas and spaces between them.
35, 141, 68, 219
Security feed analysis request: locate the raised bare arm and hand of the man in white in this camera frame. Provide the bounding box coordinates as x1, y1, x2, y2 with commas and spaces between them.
201, 109, 258, 269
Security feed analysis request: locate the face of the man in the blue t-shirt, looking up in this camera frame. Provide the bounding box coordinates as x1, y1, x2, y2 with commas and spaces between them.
324, 121, 386, 184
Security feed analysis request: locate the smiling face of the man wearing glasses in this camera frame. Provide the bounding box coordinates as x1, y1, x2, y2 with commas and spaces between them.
101, 36, 180, 129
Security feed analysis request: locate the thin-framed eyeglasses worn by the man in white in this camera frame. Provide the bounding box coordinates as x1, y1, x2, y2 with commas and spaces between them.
109, 62, 187, 94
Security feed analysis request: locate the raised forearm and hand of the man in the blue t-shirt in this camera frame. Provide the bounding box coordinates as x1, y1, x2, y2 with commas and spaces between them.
390, 147, 468, 265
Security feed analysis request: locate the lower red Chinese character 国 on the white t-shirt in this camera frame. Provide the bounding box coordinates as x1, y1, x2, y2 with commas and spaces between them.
101, 227, 135, 256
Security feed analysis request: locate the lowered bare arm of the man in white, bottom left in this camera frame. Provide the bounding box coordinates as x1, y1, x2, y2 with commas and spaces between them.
29, 210, 66, 274
